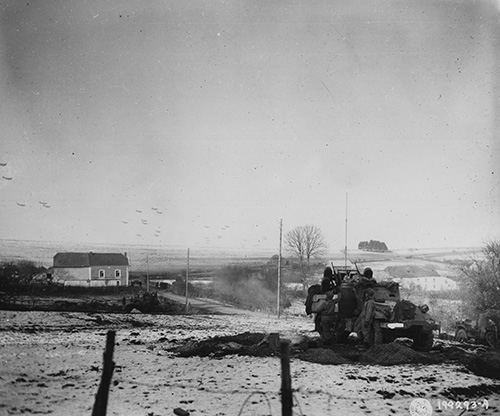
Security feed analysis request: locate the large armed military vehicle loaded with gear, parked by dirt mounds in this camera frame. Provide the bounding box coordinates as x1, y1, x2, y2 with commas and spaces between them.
310, 264, 440, 351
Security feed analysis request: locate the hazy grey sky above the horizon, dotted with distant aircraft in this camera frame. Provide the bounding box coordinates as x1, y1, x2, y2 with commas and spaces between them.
0, 0, 500, 251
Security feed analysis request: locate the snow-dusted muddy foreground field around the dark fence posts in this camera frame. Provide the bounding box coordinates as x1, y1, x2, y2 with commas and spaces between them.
0, 311, 500, 416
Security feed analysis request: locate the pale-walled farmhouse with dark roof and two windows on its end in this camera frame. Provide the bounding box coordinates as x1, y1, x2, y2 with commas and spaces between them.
51, 252, 129, 286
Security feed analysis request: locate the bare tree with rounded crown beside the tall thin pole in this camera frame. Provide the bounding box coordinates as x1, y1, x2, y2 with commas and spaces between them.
285, 225, 326, 285
